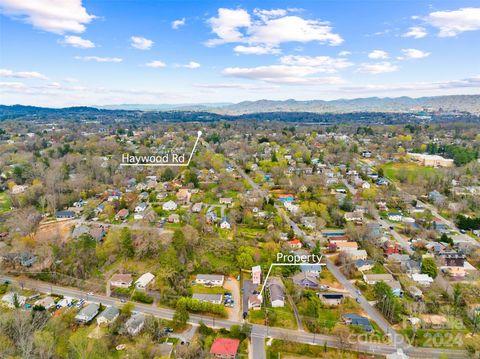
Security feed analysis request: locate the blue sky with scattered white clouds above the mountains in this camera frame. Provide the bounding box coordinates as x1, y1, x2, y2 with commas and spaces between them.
0, 0, 480, 107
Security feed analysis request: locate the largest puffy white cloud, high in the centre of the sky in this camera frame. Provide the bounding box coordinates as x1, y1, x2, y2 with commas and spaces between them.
206, 8, 343, 54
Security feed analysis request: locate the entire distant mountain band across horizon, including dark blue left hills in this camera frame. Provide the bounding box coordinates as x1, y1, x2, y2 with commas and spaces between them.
0, 95, 480, 119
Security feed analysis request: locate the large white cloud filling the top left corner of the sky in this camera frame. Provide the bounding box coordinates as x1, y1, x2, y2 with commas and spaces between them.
0, 0, 95, 34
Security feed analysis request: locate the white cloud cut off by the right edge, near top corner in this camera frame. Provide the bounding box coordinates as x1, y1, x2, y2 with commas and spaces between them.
423, 7, 480, 37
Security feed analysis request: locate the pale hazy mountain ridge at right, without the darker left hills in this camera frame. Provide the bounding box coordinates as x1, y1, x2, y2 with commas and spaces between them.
94, 95, 480, 115
